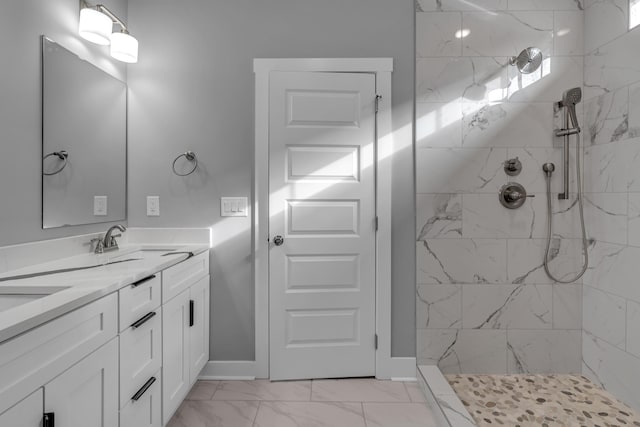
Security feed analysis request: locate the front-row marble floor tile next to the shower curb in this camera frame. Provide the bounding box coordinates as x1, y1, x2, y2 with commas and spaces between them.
362, 403, 438, 427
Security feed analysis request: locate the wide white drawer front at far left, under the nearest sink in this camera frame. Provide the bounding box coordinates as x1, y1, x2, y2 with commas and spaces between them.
0, 293, 118, 413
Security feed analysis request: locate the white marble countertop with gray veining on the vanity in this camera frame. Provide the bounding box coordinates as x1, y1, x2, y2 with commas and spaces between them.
0, 244, 209, 342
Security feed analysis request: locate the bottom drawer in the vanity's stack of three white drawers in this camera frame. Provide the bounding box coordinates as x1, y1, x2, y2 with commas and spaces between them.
120, 370, 162, 427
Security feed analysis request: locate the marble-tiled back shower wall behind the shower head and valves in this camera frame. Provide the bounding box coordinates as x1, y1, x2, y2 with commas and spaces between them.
416, 0, 584, 373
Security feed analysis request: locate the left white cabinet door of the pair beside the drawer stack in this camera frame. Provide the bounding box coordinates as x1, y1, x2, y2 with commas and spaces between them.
162, 289, 190, 424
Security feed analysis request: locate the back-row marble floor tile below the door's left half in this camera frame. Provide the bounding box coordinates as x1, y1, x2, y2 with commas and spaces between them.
213, 380, 312, 401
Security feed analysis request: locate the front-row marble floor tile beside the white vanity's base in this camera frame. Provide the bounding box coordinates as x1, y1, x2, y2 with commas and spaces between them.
167, 401, 259, 427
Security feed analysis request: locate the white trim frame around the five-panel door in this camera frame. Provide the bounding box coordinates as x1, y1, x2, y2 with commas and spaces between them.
253, 58, 394, 379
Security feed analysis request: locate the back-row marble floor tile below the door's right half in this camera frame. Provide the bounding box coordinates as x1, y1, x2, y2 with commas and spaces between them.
311, 379, 411, 402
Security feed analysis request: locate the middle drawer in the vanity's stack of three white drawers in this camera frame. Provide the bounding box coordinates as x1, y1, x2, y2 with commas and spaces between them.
120, 308, 162, 408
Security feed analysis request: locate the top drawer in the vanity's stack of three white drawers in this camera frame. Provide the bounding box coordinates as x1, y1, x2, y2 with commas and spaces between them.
118, 273, 161, 331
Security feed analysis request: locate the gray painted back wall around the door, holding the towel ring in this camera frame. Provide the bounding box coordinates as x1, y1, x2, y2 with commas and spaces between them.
129, 0, 415, 360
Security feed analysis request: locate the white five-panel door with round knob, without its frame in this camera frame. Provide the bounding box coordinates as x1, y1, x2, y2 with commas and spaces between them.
269, 72, 376, 380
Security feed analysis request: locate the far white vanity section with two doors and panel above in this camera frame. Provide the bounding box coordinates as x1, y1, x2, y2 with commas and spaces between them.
162, 254, 210, 424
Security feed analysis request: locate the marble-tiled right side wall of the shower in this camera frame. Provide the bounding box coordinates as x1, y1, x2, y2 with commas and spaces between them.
583, 0, 640, 409
